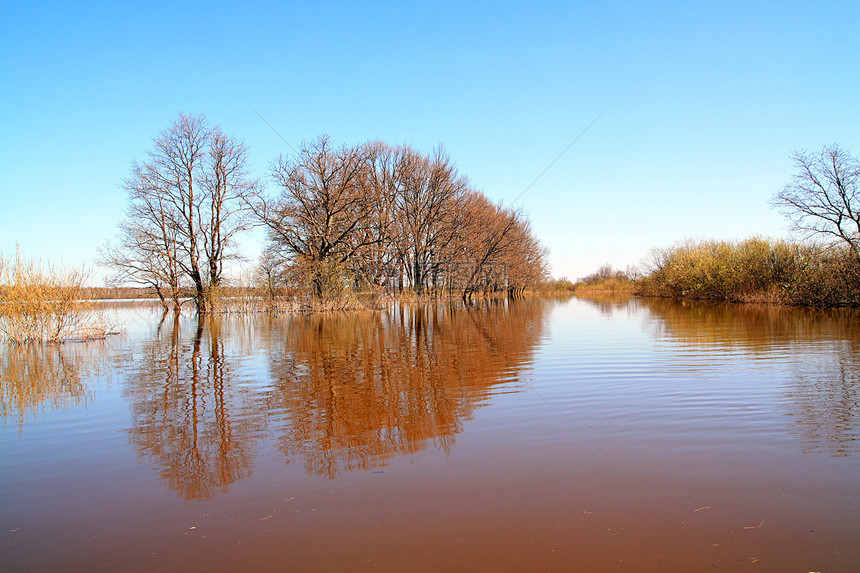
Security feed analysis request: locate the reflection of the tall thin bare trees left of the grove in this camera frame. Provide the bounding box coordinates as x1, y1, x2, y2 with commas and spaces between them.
126, 317, 265, 499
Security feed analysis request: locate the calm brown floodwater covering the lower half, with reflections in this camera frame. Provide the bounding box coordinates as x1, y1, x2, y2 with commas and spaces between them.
0, 297, 860, 572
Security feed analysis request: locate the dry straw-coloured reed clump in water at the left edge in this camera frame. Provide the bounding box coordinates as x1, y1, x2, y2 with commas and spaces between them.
0, 254, 111, 344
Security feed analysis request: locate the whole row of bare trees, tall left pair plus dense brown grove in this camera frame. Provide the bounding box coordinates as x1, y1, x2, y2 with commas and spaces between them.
100, 114, 546, 312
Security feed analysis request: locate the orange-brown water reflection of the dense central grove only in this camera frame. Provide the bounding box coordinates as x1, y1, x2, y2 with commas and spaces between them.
270, 300, 548, 477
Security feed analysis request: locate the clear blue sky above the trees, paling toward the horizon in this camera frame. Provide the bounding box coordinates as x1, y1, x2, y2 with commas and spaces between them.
0, 1, 860, 278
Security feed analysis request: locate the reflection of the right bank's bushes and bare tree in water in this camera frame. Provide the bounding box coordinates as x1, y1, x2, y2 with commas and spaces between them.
638, 299, 860, 455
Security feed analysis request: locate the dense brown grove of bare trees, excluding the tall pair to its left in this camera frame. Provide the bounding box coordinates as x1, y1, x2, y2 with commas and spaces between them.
252, 137, 546, 298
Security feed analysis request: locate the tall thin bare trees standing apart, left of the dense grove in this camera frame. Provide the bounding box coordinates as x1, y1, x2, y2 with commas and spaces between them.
101, 114, 256, 313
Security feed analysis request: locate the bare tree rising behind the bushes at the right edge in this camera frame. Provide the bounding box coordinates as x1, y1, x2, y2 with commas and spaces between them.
772, 144, 860, 259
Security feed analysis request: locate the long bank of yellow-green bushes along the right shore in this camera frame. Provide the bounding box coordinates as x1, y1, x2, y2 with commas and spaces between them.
636, 238, 860, 307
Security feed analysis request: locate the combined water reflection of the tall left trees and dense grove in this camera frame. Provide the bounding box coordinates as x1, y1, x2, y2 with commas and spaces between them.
125, 300, 548, 492
